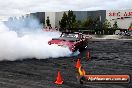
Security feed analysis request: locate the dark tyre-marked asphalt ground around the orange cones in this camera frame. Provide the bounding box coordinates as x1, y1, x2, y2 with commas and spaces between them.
0, 40, 132, 88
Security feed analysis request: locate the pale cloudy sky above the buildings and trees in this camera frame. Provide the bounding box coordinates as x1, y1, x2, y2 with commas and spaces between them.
0, 0, 132, 20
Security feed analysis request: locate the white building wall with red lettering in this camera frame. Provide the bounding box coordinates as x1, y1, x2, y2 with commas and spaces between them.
106, 10, 132, 29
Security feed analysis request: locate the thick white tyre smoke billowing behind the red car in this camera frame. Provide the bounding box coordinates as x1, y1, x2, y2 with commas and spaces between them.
0, 18, 71, 61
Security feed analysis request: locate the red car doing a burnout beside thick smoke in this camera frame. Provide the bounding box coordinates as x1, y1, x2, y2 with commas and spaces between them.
48, 32, 89, 52
